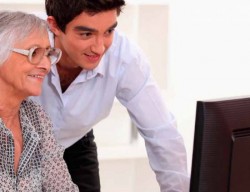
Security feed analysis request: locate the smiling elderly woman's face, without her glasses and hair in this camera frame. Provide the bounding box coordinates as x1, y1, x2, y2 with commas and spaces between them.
0, 31, 51, 99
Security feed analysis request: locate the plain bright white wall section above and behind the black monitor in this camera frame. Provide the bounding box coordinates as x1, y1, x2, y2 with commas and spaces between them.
168, 0, 250, 171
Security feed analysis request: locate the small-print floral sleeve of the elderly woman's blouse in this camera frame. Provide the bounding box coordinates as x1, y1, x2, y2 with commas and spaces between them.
35, 104, 79, 192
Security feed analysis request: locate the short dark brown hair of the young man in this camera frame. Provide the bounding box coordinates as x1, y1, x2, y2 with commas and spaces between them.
45, 0, 125, 32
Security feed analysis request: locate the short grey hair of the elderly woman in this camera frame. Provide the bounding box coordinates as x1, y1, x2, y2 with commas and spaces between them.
0, 11, 47, 65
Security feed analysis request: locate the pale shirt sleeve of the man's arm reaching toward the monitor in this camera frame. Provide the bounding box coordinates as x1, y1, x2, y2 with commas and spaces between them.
117, 39, 189, 192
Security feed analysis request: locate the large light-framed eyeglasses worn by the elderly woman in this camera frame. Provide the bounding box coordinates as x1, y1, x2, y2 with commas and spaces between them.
11, 47, 62, 65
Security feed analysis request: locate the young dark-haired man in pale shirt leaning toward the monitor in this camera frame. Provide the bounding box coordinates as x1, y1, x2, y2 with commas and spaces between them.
33, 0, 189, 192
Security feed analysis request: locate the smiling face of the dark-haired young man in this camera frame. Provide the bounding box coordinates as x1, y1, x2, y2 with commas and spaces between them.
52, 9, 117, 70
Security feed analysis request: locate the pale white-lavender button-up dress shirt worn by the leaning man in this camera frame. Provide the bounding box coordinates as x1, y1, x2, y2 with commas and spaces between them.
32, 32, 189, 192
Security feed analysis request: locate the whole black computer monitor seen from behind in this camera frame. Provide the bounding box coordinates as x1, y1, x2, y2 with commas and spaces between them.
190, 97, 250, 192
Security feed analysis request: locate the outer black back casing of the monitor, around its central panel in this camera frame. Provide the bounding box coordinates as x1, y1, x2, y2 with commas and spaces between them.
190, 96, 250, 192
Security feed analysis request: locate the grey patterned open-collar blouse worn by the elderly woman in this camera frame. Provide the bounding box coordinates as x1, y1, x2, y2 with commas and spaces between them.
0, 100, 79, 192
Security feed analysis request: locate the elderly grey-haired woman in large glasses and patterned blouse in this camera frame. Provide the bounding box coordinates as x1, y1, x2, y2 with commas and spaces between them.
0, 11, 78, 192
